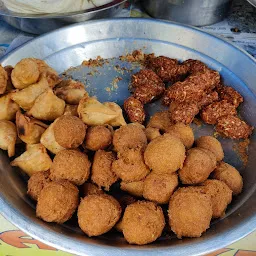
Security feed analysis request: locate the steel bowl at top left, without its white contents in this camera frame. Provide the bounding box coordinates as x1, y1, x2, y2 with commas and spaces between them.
0, 0, 127, 34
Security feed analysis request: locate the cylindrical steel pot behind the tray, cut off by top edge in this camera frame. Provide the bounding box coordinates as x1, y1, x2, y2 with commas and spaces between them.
142, 0, 232, 26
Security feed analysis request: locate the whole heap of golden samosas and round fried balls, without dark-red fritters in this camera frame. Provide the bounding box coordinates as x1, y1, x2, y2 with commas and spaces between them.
0, 58, 243, 245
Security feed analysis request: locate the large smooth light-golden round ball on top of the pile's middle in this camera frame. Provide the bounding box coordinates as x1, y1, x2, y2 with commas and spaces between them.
144, 133, 185, 173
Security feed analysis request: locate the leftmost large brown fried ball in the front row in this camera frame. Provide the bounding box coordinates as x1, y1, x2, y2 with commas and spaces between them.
36, 180, 79, 223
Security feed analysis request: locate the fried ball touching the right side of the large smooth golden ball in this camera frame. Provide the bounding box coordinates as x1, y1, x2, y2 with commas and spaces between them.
179, 148, 216, 184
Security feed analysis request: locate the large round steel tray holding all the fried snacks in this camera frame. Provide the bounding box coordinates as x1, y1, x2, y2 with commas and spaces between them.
0, 19, 256, 256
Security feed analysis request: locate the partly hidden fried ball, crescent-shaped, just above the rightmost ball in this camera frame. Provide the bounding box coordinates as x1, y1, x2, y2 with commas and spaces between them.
196, 136, 224, 161
